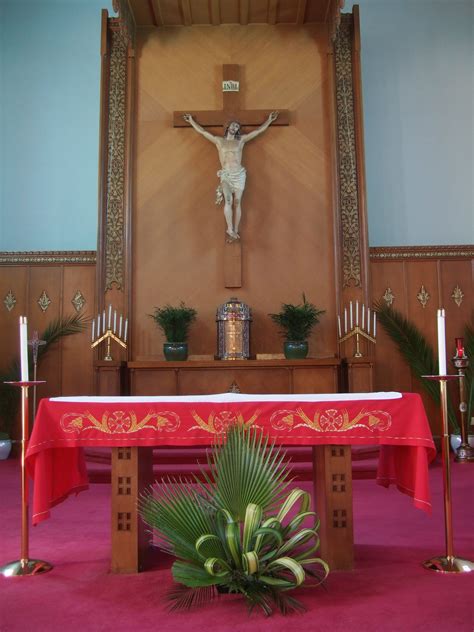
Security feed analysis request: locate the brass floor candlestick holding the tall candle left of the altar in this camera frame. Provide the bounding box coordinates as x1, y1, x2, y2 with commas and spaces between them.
0, 381, 53, 577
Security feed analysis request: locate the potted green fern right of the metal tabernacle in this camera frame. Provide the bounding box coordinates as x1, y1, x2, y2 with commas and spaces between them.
269, 293, 324, 360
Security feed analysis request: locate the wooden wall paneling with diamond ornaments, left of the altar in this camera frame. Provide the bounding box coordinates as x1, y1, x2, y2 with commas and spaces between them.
0, 251, 96, 440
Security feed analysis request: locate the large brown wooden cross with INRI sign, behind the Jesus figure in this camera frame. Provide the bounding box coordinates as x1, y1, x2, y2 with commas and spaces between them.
173, 64, 290, 288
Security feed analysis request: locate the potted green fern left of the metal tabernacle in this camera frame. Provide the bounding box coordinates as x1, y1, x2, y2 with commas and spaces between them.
150, 301, 197, 361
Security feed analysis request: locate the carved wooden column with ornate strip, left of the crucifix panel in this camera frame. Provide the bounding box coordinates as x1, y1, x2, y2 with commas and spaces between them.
97, 3, 135, 370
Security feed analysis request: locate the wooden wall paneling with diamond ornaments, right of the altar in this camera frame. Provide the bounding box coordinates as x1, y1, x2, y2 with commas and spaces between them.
370, 245, 474, 435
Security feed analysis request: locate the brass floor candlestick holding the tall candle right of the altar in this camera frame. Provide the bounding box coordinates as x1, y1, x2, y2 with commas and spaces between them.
422, 375, 474, 573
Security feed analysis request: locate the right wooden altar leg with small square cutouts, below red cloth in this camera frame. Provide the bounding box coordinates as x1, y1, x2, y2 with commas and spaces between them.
313, 445, 354, 570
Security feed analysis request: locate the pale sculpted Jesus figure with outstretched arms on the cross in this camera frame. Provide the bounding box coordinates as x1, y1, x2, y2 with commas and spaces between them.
183, 112, 278, 241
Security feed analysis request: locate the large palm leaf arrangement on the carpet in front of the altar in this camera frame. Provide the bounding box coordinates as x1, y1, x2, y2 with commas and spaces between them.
139, 425, 329, 616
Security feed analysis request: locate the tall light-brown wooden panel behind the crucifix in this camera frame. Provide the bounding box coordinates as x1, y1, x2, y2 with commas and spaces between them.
131, 25, 336, 360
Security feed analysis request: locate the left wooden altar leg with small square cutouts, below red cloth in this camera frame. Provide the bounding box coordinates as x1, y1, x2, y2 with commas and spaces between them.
111, 448, 153, 573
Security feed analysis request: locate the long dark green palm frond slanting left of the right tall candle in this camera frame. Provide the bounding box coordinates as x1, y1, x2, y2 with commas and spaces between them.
374, 301, 459, 432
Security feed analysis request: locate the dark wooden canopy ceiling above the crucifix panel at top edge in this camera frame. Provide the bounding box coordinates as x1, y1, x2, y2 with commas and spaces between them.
124, 0, 344, 27
